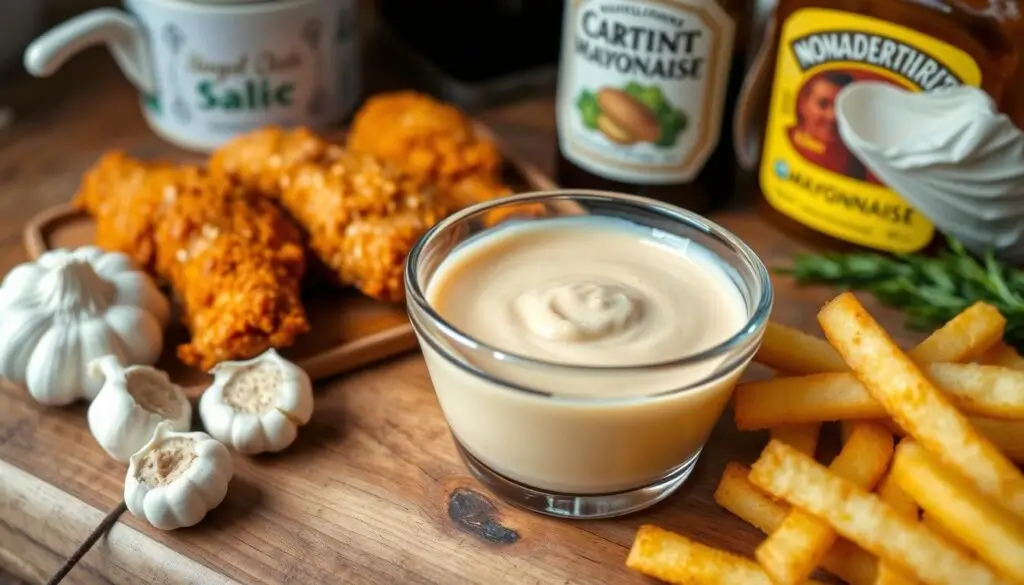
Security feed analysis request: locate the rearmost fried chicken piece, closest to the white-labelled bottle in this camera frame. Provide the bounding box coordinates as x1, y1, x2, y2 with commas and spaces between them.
347, 91, 512, 208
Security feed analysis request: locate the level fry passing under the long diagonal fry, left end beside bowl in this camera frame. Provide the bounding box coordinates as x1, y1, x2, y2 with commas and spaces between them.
732, 364, 1024, 430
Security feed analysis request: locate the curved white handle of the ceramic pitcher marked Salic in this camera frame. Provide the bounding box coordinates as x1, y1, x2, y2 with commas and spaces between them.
24, 8, 157, 95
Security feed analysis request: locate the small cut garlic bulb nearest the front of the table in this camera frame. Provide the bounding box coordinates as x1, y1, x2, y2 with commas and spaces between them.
125, 421, 234, 530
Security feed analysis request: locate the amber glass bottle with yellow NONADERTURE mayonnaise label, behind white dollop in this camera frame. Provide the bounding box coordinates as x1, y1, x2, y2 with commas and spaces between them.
739, 0, 1024, 252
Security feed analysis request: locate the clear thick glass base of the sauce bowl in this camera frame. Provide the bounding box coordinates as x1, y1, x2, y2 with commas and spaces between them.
452, 436, 700, 519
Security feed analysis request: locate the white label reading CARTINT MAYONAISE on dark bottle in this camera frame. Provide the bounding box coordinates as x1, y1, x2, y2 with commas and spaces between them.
556, 0, 734, 184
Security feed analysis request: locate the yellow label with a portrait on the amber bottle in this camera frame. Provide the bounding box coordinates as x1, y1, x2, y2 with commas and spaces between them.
760, 8, 981, 252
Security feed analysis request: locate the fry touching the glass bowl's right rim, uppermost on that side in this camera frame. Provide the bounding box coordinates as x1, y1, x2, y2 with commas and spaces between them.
754, 321, 850, 375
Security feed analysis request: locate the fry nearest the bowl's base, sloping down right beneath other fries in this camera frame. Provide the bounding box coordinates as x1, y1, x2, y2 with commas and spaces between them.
715, 463, 878, 585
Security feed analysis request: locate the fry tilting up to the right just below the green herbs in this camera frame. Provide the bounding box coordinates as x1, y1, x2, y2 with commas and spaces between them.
909, 305, 1007, 364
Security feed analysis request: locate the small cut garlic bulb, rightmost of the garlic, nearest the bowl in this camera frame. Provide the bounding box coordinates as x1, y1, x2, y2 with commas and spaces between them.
199, 349, 313, 455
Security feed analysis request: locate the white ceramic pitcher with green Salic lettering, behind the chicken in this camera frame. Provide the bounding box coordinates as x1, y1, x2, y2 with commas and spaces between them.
25, 0, 359, 152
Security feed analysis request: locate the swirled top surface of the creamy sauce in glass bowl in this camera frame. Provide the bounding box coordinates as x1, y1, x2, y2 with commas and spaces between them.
427, 217, 746, 366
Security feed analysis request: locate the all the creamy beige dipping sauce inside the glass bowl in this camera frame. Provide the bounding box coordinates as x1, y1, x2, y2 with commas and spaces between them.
421, 216, 753, 494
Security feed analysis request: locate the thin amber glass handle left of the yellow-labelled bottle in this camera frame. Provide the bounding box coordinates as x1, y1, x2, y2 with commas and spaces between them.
732, 14, 778, 171
